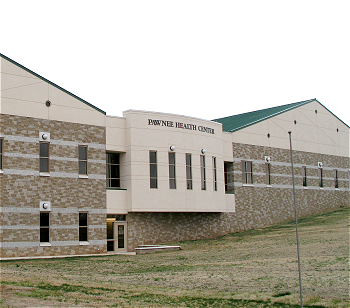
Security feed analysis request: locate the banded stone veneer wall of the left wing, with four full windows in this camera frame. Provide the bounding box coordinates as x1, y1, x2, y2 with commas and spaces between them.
0, 114, 106, 258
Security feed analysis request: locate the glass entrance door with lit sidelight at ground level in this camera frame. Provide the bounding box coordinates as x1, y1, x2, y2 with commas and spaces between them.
107, 219, 127, 252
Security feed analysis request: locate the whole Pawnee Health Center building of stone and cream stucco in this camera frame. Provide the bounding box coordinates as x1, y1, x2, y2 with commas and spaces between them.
0, 54, 350, 259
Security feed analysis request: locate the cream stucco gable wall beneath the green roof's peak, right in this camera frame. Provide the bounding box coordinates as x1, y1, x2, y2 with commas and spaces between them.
231, 101, 349, 157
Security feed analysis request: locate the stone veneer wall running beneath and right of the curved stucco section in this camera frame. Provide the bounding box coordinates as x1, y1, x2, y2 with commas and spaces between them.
127, 143, 350, 251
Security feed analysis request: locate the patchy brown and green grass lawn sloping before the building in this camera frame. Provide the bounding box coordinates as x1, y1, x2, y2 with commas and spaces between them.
0, 208, 350, 307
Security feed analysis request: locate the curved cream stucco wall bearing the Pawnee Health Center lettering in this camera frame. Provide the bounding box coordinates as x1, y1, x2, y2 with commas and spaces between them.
107, 110, 234, 212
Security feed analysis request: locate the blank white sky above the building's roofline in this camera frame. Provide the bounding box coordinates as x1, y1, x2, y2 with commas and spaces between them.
0, 0, 350, 125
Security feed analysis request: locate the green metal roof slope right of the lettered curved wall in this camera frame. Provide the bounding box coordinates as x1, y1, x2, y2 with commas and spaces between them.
213, 98, 317, 132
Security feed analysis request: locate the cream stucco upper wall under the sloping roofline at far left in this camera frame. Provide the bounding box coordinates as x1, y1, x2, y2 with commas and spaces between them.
0, 58, 105, 126
